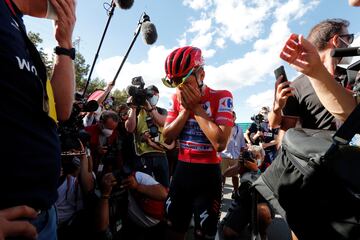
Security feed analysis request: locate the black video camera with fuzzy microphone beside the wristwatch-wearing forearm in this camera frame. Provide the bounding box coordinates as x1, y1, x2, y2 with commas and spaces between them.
58, 94, 99, 155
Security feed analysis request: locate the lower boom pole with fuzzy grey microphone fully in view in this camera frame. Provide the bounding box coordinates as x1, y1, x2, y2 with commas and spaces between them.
112, 12, 158, 86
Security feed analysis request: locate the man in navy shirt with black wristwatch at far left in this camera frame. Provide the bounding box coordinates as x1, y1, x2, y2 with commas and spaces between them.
0, 0, 75, 239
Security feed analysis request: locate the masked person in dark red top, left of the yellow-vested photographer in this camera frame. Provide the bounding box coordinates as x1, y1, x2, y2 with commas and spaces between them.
85, 111, 121, 175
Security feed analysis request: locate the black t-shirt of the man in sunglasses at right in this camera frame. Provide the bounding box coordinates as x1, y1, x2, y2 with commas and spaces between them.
283, 74, 336, 130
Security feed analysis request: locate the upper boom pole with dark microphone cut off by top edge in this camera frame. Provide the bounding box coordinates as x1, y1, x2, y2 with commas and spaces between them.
82, 0, 134, 97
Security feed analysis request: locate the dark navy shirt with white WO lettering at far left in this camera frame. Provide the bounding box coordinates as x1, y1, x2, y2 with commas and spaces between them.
0, 0, 60, 209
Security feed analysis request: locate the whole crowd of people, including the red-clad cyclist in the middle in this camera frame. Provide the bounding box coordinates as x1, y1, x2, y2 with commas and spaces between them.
0, 0, 360, 240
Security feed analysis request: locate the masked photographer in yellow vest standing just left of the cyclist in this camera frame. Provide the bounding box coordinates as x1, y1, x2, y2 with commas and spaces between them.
125, 85, 171, 188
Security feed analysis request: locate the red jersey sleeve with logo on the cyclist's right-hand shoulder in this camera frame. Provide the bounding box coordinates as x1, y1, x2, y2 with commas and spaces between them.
215, 90, 234, 127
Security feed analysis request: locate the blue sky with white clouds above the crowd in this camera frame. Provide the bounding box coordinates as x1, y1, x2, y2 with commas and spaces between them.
24, 0, 360, 122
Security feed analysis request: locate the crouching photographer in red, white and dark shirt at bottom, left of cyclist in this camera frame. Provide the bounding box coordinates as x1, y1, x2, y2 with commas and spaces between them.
98, 172, 167, 240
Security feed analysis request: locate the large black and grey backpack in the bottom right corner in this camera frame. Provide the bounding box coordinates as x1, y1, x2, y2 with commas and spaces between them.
262, 105, 360, 240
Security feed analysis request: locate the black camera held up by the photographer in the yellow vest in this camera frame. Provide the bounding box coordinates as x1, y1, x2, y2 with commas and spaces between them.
126, 76, 153, 106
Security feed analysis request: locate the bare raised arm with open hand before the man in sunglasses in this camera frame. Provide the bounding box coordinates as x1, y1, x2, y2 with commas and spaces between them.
280, 34, 356, 121
